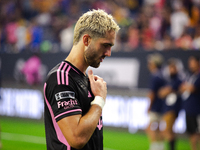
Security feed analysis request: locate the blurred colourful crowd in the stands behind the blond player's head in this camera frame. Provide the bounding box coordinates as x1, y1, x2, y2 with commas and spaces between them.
0, 0, 200, 53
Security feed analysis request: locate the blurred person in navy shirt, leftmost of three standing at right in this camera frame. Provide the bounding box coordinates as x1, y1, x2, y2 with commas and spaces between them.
146, 53, 165, 150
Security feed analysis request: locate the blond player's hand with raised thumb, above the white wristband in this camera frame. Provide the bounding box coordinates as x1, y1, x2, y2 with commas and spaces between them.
88, 70, 107, 100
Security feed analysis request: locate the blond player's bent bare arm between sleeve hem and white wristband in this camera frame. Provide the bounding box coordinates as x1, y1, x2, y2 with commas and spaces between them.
58, 105, 102, 149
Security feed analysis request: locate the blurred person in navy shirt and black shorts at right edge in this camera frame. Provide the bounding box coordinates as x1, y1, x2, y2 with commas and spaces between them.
180, 56, 200, 150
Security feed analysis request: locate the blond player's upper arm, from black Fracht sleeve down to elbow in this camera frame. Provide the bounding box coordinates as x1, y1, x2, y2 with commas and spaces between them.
45, 84, 89, 149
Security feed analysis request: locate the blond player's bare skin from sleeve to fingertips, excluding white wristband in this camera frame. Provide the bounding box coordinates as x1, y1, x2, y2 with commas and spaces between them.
58, 71, 107, 149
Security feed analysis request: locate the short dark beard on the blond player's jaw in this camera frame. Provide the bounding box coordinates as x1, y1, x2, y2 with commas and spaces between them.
84, 45, 100, 68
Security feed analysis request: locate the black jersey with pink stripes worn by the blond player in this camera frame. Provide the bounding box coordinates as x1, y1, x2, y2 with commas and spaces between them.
44, 61, 103, 150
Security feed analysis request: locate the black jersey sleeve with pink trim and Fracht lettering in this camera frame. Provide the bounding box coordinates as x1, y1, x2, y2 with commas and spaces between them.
46, 82, 82, 122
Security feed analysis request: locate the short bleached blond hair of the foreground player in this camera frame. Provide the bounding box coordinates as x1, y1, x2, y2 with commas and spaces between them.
73, 9, 120, 45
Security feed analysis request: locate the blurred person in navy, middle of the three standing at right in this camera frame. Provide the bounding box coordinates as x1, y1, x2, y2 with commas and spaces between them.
158, 58, 182, 150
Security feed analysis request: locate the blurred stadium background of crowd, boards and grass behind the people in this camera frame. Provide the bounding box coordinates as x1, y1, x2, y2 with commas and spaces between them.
0, 0, 200, 150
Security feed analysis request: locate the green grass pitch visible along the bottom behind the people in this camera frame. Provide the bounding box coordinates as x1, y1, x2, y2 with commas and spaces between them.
0, 117, 190, 150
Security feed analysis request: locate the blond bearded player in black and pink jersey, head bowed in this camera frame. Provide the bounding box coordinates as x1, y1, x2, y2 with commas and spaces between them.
44, 9, 119, 150
